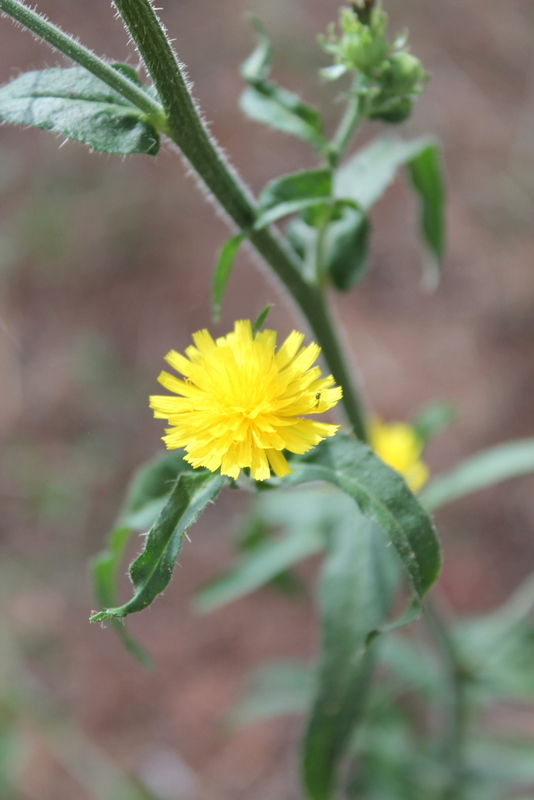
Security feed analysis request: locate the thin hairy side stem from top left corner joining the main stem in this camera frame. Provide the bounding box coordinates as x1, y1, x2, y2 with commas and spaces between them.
0, 0, 166, 126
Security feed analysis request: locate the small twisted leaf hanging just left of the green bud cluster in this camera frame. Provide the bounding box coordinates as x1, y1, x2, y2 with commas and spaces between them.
240, 17, 326, 152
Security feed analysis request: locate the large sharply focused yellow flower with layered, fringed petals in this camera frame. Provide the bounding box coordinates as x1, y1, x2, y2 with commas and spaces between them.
150, 320, 342, 481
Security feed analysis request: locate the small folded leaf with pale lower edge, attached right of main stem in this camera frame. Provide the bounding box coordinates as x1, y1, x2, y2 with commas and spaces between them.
254, 169, 332, 230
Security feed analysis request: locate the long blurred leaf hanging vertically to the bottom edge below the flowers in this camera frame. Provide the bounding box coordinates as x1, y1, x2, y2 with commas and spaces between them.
302, 508, 398, 800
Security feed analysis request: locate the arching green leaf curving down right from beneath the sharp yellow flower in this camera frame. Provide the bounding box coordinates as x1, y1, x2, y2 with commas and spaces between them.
283, 433, 441, 598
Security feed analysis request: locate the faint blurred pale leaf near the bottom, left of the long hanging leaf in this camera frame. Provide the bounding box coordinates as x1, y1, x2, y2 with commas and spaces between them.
230, 661, 315, 727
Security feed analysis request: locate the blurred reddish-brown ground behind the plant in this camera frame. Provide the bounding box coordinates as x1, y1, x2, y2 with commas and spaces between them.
0, 0, 534, 800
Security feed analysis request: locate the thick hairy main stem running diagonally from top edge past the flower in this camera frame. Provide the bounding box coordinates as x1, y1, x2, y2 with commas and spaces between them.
114, 0, 372, 440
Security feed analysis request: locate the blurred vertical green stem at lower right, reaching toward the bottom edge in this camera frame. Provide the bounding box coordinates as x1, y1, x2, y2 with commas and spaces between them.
424, 597, 467, 800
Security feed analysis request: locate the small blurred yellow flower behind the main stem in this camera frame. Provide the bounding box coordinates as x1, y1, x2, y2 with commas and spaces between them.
369, 418, 429, 492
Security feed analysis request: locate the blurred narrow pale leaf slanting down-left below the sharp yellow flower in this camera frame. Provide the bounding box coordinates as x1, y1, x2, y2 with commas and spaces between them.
194, 528, 324, 613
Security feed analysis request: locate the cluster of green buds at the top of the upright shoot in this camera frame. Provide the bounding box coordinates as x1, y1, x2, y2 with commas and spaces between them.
321, 5, 428, 122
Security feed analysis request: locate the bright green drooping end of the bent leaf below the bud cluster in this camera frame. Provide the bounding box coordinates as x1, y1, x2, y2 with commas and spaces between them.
406, 142, 445, 287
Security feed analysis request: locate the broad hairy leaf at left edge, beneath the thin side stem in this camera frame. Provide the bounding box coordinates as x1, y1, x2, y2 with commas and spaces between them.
0, 67, 159, 155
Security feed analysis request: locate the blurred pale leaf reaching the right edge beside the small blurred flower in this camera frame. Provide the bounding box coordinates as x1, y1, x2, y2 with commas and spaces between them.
420, 439, 534, 511
